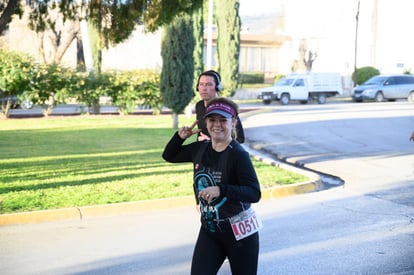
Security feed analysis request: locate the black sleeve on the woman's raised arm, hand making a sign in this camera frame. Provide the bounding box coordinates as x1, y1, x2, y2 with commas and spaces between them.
162, 131, 195, 163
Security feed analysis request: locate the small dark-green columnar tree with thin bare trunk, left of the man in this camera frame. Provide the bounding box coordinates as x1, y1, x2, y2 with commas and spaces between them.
160, 15, 195, 128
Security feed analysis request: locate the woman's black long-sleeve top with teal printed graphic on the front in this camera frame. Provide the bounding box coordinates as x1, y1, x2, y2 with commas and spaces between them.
162, 132, 261, 232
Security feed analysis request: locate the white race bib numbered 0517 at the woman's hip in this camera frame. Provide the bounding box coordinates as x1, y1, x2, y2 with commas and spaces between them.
230, 208, 263, 241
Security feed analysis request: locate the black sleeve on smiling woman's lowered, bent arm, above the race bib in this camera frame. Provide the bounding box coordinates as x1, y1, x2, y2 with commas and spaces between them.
219, 147, 261, 203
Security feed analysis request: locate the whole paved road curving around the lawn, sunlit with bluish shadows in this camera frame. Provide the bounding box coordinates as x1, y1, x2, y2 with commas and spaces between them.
0, 102, 414, 274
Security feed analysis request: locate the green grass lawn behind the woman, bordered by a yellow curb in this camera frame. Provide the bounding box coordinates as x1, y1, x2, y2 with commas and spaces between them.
0, 115, 306, 214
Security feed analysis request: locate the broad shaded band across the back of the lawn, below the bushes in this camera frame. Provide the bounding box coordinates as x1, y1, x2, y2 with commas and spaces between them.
0, 128, 174, 157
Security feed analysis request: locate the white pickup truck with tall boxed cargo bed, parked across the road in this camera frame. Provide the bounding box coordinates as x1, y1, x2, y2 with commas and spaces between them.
259, 73, 342, 105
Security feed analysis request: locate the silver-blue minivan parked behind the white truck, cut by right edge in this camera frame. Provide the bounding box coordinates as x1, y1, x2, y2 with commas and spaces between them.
352, 75, 414, 102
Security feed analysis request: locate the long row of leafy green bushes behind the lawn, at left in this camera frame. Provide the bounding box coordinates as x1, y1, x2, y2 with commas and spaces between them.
0, 50, 162, 118
